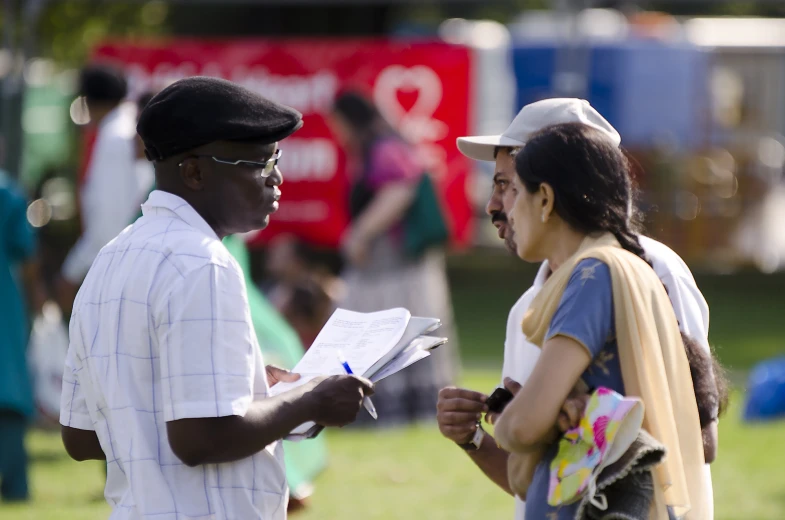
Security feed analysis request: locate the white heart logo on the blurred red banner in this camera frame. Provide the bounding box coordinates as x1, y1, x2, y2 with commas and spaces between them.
373, 65, 448, 142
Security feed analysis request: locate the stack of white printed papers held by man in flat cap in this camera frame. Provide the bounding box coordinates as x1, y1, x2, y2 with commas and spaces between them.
270, 308, 447, 440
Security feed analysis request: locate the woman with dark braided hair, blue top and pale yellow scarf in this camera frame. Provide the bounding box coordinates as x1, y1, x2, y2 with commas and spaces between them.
495, 123, 708, 520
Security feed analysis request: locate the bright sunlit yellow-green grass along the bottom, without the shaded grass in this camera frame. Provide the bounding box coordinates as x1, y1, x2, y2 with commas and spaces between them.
9, 371, 785, 520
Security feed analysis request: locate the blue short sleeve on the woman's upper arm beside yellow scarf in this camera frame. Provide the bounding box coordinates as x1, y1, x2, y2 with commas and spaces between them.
546, 258, 614, 358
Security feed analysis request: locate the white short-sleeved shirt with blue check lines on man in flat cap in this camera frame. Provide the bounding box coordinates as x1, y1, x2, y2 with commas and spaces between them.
60, 191, 288, 520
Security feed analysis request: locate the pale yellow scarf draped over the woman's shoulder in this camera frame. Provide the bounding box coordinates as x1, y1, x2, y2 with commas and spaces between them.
523, 233, 709, 520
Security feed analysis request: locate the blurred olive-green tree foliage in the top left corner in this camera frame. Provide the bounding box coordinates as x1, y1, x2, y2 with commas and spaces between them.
36, 0, 169, 66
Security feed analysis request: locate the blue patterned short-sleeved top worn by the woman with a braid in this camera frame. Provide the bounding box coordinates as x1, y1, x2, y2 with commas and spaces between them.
526, 258, 624, 520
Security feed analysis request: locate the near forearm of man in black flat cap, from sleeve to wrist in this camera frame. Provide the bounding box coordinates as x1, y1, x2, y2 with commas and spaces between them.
167, 389, 313, 466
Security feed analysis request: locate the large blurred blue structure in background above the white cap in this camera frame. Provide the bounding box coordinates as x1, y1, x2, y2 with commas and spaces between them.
512, 40, 711, 150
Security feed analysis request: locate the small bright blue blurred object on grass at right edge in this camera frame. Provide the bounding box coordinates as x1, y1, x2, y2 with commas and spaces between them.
744, 356, 785, 421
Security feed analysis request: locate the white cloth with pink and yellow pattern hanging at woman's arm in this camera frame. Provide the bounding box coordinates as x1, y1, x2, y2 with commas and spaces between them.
548, 387, 644, 507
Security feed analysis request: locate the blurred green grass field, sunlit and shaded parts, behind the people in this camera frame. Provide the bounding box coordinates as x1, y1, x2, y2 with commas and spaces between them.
0, 259, 785, 520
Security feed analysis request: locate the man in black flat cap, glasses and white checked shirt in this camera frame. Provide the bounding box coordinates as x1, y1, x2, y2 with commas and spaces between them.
60, 77, 373, 520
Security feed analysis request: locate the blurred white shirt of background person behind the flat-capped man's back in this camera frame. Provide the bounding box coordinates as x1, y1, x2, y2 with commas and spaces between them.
62, 103, 153, 284
